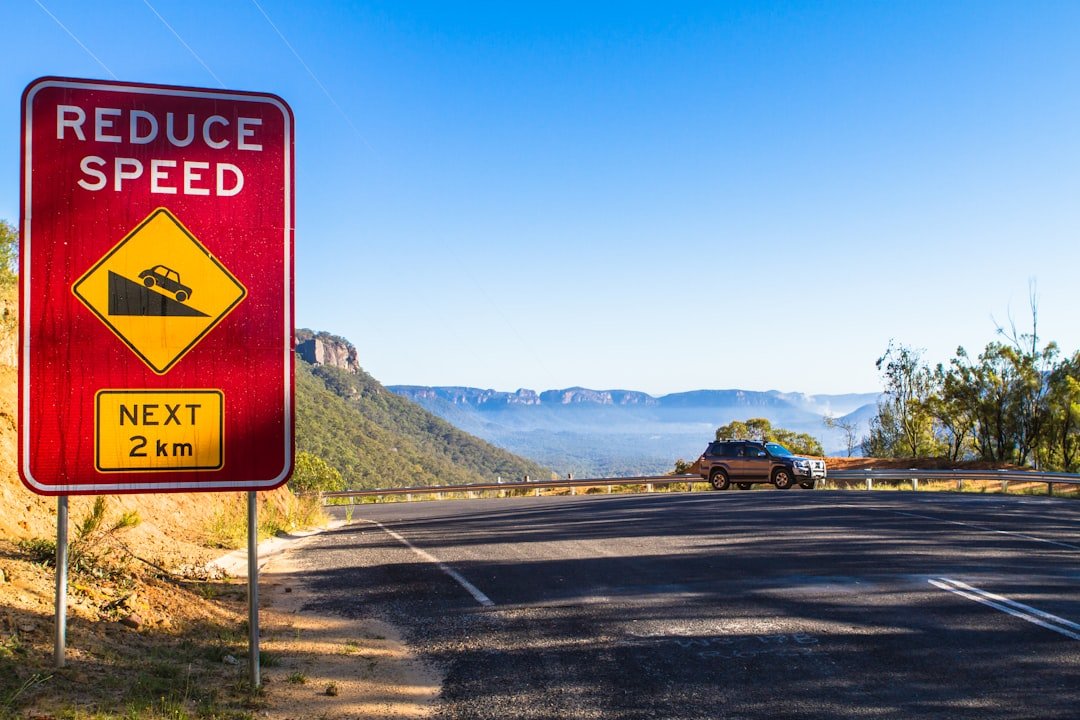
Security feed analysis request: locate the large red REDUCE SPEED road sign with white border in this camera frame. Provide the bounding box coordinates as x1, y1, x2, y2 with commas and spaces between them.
18, 78, 294, 494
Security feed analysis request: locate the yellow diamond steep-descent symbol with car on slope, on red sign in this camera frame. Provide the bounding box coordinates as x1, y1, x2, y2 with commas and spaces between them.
71, 207, 247, 375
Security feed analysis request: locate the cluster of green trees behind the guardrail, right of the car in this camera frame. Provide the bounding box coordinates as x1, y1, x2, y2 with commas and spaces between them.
863, 299, 1080, 472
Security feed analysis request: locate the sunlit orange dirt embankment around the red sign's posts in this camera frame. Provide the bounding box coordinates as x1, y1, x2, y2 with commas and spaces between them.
0, 280, 440, 720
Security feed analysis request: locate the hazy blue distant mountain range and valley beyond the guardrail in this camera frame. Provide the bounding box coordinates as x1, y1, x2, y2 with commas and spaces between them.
388, 385, 879, 477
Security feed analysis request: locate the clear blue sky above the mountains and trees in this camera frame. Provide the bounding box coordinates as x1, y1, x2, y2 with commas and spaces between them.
0, 0, 1080, 394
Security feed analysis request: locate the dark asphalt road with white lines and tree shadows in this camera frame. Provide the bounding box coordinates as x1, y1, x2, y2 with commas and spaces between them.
289, 490, 1080, 720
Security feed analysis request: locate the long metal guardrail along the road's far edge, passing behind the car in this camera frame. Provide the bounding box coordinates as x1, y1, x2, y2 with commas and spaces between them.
321, 467, 1080, 502
